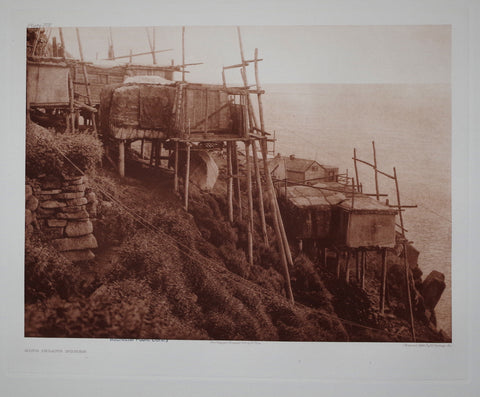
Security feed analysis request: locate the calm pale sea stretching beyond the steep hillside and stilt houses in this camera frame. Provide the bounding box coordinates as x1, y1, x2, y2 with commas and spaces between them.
262, 84, 452, 335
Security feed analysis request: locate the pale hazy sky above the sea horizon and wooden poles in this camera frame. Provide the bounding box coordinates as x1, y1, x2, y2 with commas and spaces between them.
59, 25, 451, 84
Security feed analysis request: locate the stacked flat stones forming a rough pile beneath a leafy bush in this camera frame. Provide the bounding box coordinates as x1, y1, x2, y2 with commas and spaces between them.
25, 176, 98, 262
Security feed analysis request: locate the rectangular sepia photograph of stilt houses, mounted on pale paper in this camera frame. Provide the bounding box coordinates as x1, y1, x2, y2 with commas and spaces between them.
24, 25, 452, 343
